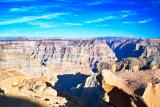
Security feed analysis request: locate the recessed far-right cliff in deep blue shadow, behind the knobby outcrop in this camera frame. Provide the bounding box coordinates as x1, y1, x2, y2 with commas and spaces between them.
106, 39, 160, 60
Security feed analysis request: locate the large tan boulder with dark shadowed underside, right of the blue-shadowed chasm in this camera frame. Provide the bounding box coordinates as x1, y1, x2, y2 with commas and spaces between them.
98, 70, 146, 107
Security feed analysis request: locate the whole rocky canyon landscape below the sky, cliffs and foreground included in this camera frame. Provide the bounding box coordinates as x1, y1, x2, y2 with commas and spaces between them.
0, 38, 160, 107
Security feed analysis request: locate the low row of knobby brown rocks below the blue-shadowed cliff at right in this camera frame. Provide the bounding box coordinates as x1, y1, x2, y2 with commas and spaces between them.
98, 57, 160, 72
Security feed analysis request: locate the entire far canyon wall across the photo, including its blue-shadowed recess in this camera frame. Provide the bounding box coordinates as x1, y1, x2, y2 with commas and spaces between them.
0, 39, 160, 75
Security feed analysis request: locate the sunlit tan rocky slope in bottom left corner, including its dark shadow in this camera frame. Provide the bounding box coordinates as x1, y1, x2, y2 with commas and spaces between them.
0, 70, 68, 107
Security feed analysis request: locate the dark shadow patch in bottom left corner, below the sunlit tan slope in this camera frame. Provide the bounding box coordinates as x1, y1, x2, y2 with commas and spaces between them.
0, 95, 42, 107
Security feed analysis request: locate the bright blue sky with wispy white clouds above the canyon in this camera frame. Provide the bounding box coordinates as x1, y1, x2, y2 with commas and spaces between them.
0, 0, 160, 38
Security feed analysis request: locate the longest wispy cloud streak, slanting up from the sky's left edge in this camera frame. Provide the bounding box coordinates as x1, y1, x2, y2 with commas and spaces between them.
0, 13, 69, 25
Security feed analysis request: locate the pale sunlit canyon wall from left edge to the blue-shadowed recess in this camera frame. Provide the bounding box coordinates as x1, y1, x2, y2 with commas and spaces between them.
0, 40, 116, 74
